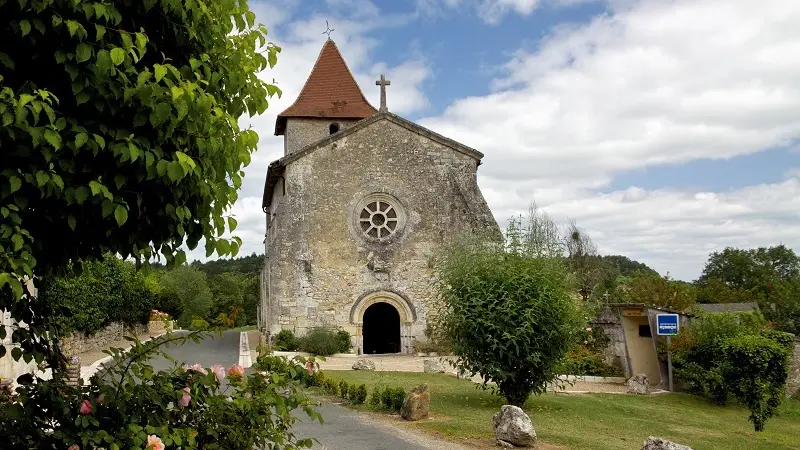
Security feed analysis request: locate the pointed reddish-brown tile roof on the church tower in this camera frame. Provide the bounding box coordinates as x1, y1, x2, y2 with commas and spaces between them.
275, 39, 378, 136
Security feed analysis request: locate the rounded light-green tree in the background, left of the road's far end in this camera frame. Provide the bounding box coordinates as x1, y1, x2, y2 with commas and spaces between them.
161, 265, 214, 328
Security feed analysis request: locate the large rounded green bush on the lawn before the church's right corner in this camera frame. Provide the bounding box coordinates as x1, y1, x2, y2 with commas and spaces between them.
429, 239, 580, 406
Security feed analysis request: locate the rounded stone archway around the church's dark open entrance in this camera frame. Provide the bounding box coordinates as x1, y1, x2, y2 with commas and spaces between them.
350, 291, 416, 354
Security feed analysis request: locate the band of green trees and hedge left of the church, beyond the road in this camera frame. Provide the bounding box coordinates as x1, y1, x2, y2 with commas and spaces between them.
39, 254, 262, 334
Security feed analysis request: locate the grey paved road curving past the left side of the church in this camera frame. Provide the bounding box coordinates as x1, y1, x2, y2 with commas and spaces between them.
138, 331, 450, 450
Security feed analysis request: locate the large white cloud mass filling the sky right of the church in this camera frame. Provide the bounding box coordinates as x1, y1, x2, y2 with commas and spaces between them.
421, 0, 800, 279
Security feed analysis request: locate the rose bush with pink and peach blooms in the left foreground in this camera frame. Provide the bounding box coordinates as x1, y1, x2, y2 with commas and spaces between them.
0, 333, 319, 450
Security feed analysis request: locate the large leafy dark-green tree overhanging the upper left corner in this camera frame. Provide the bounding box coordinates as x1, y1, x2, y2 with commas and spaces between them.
0, 0, 280, 365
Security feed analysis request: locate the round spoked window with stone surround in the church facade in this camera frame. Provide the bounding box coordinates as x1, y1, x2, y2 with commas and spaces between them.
354, 193, 405, 241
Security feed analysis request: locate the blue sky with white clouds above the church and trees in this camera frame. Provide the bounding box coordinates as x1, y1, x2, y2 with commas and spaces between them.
188, 0, 800, 281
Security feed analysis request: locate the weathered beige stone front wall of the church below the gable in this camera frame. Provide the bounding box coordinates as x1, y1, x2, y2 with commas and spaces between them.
262, 115, 497, 351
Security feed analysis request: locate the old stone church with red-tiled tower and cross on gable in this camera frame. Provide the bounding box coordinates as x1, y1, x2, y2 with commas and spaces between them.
259, 40, 499, 354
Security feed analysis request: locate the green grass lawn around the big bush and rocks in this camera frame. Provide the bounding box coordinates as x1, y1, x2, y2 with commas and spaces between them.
325, 371, 800, 450
